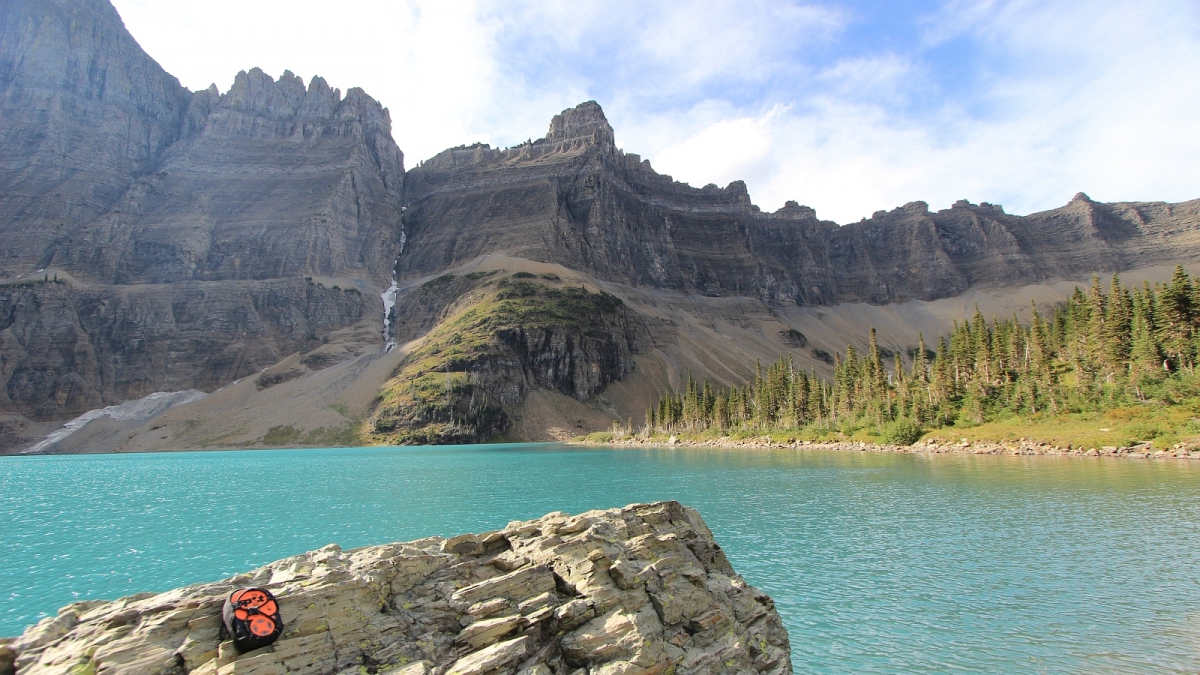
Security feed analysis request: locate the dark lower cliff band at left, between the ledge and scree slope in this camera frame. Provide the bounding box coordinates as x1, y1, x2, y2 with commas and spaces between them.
0, 279, 367, 419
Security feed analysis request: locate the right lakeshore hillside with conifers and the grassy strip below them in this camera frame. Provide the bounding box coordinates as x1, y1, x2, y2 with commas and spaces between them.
630, 267, 1200, 448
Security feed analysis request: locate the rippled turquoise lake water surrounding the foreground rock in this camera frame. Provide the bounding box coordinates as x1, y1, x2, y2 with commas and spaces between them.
0, 446, 1200, 674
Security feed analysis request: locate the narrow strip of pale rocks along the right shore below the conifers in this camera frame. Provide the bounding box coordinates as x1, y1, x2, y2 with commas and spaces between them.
570, 436, 1200, 460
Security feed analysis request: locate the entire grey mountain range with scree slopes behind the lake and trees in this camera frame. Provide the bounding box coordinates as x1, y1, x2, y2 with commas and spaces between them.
0, 0, 1200, 450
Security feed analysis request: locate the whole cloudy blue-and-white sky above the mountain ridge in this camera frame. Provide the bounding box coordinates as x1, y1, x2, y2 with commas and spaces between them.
113, 0, 1200, 223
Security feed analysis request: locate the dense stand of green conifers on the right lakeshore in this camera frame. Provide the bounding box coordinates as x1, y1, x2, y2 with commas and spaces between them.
646, 269, 1200, 441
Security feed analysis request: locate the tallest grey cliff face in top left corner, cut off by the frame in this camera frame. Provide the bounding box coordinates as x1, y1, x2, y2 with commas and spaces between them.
0, 0, 191, 267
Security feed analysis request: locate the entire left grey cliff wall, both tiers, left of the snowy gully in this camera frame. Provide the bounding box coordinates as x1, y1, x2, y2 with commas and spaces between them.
0, 0, 404, 419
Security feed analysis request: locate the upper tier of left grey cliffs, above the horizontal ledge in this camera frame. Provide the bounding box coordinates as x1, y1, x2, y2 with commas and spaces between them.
0, 0, 404, 285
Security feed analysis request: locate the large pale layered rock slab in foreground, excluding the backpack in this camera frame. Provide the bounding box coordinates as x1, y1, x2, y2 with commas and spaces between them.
11, 502, 792, 675
